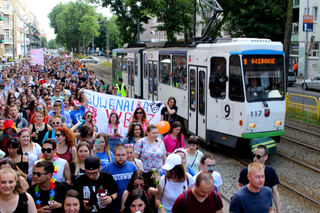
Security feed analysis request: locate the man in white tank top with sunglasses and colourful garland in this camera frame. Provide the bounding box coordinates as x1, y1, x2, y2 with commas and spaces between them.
32, 138, 71, 185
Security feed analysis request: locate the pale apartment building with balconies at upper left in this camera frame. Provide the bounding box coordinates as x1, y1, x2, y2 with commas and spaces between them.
0, 0, 41, 59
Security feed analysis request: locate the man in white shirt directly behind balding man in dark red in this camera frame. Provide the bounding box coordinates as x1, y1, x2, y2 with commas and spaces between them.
193, 153, 222, 194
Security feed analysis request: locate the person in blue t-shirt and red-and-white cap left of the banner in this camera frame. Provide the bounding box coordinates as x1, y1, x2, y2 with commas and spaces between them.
69, 89, 88, 125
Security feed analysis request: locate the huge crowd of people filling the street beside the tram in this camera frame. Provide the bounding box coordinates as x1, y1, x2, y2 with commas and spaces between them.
0, 57, 280, 213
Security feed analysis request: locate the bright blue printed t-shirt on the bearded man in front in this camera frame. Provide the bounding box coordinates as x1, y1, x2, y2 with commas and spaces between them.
101, 161, 138, 211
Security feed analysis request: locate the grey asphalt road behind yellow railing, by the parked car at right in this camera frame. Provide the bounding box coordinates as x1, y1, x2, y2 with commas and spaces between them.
287, 84, 320, 106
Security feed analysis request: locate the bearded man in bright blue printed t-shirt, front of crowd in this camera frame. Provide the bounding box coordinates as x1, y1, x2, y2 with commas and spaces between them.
102, 144, 138, 212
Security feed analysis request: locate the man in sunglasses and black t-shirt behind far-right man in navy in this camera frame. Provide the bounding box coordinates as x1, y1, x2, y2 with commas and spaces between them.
237, 145, 281, 213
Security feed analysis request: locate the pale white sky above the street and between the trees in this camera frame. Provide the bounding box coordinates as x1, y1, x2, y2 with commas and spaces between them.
25, 0, 112, 41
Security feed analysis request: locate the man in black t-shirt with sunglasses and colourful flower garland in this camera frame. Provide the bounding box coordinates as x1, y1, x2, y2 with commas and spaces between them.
27, 161, 68, 213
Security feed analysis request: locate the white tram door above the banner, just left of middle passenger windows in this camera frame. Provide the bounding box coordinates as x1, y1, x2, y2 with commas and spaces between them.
148, 61, 158, 101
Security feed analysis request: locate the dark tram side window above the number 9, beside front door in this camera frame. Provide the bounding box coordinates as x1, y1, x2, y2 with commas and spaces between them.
209, 57, 227, 99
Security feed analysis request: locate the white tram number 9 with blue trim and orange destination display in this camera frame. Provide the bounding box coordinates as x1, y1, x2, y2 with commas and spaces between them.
112, 0, 286, 153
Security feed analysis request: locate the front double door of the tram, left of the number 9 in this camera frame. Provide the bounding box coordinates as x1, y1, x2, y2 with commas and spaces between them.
188, 66, 207, 140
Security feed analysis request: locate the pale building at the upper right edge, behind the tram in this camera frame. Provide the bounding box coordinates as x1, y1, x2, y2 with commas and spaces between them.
290, 0, 320, 78
